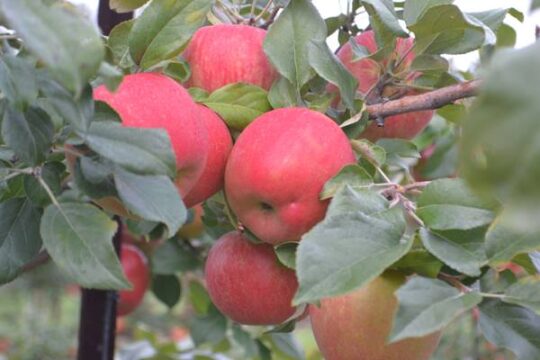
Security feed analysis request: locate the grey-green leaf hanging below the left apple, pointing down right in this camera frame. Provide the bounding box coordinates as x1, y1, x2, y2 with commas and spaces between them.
114, 167, 187, 235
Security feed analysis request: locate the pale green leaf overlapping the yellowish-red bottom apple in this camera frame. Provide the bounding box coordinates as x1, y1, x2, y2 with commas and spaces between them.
390, 277, 482, 342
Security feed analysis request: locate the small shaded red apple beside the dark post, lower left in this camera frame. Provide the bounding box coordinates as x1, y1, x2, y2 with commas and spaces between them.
117, 244, 150, 316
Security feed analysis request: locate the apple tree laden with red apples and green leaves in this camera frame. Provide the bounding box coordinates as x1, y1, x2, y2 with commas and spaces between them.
0, 0, 540, 360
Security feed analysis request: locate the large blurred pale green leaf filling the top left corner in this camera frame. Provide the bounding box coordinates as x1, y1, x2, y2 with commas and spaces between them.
0, 0, 105, 96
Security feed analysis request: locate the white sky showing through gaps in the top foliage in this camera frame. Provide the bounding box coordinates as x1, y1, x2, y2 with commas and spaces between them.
70, 0, 540, 70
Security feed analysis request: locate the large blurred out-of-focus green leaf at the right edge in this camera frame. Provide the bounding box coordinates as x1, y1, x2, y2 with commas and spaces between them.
460, 43, 540, 209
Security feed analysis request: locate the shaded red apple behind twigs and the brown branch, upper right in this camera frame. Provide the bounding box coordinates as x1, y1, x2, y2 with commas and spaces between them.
336, 31, 433, 141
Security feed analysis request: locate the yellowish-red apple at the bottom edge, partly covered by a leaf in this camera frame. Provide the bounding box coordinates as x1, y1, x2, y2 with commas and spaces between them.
309, 272, 440, 360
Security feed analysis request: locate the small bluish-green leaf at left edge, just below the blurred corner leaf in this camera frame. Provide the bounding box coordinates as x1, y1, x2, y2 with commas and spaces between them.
0, 54, 38, 110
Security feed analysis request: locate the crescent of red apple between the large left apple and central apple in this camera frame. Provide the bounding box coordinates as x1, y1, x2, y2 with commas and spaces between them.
184, 105, 233, 208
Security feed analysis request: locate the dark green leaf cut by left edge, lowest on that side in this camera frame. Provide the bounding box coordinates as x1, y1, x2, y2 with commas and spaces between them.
0, 198, 41, 284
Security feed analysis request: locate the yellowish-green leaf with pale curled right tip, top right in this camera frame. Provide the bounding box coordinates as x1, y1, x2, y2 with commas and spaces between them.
409, 5, 495, 54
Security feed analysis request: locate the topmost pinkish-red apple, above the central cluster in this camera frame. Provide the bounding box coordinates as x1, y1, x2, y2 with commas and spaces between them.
183, 24, 278, 92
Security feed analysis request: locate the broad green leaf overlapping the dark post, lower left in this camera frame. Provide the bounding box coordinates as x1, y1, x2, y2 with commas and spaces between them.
40, 202, 129, 289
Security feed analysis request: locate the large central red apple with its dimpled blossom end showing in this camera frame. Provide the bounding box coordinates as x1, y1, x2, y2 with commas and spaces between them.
225, 108, 356, 245
